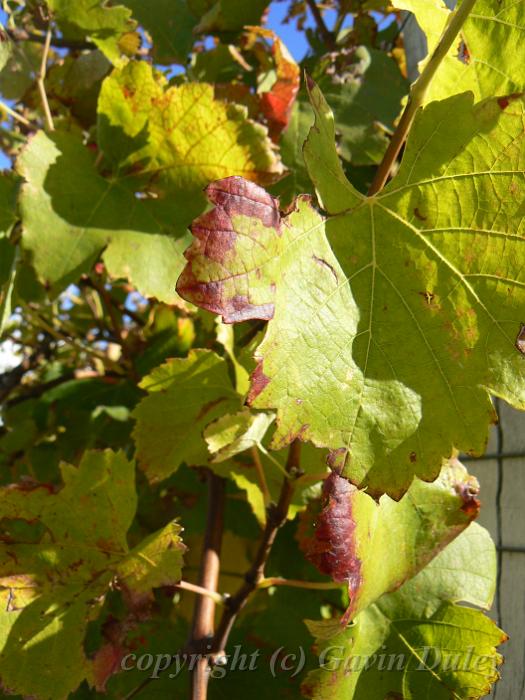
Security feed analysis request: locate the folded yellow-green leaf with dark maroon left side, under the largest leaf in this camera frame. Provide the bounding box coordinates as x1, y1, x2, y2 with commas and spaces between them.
300, 462, 479, 623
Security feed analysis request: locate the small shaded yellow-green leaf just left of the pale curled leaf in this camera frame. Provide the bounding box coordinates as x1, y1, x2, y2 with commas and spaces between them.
133, 350, 240, 481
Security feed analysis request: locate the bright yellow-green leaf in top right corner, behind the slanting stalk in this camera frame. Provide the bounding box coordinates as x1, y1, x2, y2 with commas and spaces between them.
392, 0, 525, 102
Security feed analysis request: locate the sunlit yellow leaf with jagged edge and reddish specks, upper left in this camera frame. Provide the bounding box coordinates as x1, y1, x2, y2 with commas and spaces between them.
98, 62, 282, 191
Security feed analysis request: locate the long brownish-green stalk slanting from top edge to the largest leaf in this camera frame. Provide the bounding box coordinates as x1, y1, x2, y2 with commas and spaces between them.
368, 0, 476, 197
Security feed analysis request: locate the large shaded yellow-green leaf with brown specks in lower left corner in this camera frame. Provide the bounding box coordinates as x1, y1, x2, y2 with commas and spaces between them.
0, 450, 185, 700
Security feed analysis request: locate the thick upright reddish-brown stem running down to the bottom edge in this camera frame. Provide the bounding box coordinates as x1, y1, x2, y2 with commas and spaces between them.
188, 471, 226, 700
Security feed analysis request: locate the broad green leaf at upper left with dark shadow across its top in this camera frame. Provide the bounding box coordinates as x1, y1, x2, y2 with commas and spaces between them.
17, 132, 188, 302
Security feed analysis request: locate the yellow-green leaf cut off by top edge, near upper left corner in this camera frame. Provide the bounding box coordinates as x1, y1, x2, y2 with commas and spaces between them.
47, 0, 135, 64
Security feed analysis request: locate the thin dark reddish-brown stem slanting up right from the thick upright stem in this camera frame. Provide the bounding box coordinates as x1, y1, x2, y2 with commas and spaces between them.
208, 440, 301, 660
